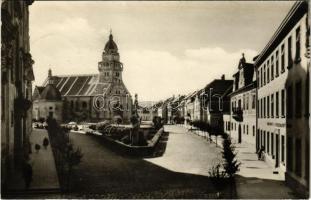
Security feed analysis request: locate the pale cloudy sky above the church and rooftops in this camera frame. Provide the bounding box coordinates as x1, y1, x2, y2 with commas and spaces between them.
29, 1, 294, 101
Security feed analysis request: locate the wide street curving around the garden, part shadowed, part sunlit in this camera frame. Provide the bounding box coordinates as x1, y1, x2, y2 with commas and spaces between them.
70, 126, 224, 198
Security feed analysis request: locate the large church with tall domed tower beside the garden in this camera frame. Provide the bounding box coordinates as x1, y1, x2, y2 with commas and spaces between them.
33, 33, 132, 123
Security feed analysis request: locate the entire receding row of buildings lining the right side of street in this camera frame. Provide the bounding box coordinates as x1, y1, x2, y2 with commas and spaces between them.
144, 1, 310, 196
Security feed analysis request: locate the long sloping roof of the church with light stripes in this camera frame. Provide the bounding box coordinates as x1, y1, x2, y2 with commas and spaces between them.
43, 74, 110, 96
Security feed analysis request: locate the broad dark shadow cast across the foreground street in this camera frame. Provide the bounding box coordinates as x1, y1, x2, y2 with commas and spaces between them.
66, 133, 231, 198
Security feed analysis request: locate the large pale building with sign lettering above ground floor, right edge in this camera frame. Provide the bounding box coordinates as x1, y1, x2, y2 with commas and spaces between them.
255, 1, 310, 196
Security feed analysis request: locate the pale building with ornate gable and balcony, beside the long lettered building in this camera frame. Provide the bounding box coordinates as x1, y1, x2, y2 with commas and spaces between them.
224, 55, 257, 147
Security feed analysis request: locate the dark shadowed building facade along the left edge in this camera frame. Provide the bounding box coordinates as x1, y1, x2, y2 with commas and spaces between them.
1, 0, 34, 191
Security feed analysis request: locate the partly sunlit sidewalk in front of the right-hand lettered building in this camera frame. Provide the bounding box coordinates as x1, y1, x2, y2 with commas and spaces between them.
235, 142, 297, 199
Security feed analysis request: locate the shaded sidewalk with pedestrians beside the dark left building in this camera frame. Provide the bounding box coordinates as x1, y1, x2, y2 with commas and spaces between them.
30, 129, 59, 190
